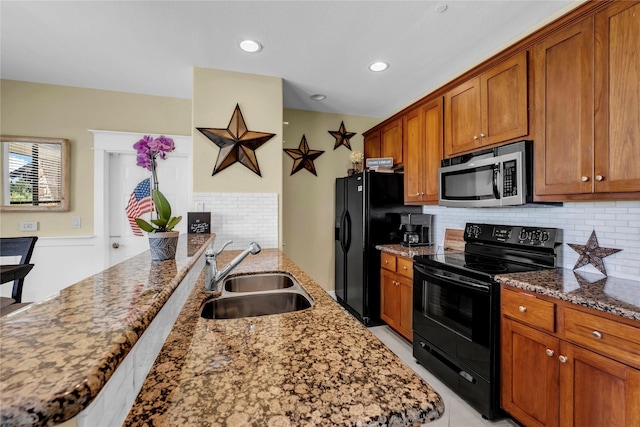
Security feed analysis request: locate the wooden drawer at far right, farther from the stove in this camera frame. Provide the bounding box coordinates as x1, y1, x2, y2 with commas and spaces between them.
560, 307, 640, 368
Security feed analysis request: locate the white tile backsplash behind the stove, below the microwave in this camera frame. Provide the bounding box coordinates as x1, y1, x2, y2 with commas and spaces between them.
423, 201, 640, 280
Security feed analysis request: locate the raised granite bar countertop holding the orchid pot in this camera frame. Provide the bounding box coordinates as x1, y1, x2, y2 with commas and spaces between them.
0, 234, 214, 426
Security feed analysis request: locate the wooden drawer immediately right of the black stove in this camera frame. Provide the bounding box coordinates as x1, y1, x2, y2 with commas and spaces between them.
502, 289, 556, 332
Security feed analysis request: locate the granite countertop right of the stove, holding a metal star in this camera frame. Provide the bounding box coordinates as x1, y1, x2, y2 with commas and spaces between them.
495, 268, 640, 321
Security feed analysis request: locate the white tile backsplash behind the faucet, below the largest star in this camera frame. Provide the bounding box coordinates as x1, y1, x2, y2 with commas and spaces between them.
193, 193, 278, 249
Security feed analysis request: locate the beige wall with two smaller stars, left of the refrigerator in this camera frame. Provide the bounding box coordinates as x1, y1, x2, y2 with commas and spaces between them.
282, 109, 380, 291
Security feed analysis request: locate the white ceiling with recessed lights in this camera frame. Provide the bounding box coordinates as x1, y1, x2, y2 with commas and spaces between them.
0, 0, 583, 118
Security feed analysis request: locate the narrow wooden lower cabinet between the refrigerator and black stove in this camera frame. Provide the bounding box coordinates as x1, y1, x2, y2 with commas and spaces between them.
380, 252, 413, 341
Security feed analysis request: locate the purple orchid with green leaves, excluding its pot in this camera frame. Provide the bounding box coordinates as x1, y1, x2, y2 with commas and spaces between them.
133, 135, 182, 233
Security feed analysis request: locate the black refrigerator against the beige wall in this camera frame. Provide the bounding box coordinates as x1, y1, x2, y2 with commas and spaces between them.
335, 171, 422, 326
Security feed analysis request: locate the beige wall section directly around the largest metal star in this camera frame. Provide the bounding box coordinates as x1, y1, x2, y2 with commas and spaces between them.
193, 68, 282, 195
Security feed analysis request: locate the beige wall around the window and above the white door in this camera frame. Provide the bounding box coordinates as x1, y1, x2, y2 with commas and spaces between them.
0, 80, 191, 237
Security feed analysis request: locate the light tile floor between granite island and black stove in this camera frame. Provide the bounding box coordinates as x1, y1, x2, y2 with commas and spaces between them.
369, 325, 518, 427
